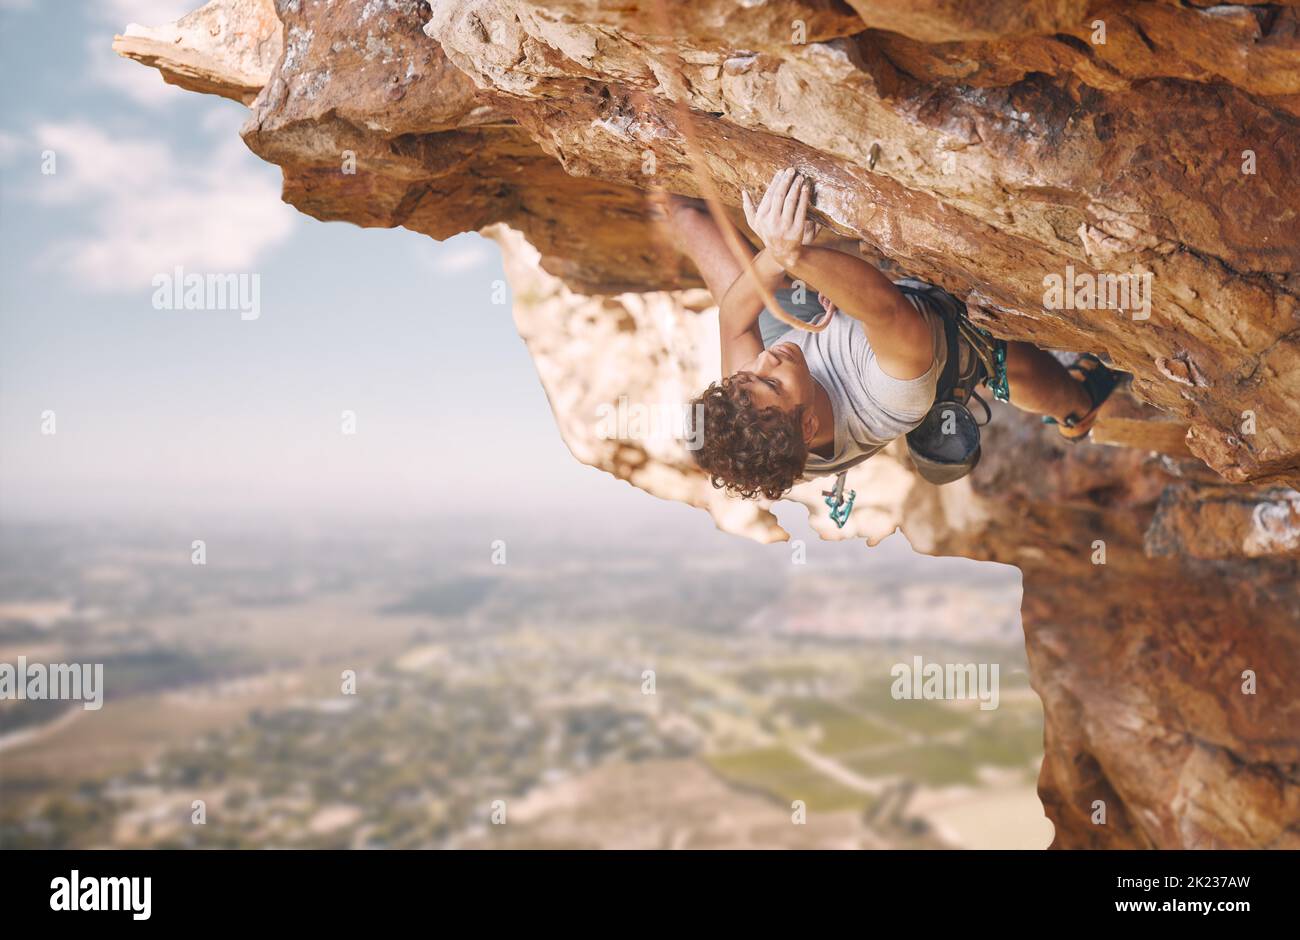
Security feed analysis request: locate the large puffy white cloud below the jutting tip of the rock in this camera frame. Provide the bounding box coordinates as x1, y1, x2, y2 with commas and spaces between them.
33, 121, 294, 291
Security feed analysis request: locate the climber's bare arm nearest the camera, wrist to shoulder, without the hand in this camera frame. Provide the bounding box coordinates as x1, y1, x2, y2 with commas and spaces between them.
787, 246, 935, 380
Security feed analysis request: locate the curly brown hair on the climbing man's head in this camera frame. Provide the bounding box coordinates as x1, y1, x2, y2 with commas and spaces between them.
689, 372, 807, 499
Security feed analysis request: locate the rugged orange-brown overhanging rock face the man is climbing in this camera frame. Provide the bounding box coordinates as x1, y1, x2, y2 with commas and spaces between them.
117, 0, 1300, 848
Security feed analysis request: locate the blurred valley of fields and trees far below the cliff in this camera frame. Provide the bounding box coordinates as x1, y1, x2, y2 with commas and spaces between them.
0, 516, 1052, 848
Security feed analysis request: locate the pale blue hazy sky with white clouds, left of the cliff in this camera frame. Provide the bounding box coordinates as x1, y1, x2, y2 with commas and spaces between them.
0, 0, 982, 566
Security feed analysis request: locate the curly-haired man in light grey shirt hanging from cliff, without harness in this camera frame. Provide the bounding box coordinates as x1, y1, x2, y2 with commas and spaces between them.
666, 168, 1121, 499
